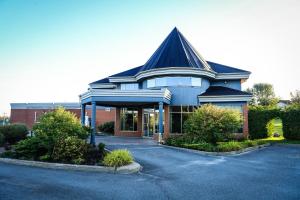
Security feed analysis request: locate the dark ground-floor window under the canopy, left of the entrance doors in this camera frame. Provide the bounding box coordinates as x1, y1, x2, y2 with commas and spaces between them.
120, 108, 138, 131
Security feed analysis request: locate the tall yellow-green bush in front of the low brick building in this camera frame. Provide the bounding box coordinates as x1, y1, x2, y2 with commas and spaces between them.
33, 108, 88, 140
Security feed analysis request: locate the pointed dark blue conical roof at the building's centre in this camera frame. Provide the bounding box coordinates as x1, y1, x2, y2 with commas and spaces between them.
140, 27, 212, 71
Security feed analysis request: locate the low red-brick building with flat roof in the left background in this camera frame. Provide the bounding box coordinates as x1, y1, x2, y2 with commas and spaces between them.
10, 103, 115, 129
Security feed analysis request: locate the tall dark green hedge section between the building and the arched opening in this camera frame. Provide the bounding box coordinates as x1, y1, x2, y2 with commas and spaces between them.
248, 106, 282, 139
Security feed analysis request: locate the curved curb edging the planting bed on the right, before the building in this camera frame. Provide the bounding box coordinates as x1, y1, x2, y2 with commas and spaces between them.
160, 143, 271, 156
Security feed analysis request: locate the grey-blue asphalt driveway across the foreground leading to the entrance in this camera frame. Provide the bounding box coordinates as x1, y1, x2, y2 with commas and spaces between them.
0, 137, 300, 199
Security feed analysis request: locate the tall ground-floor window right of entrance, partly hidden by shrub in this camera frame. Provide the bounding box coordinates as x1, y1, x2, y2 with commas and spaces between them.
170, 106, 197, 134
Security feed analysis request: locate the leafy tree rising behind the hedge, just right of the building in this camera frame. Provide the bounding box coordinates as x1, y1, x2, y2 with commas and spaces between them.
247, 83, 279, 106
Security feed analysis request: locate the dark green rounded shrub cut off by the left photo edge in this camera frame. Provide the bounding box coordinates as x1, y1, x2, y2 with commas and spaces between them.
0, 124, 28, 144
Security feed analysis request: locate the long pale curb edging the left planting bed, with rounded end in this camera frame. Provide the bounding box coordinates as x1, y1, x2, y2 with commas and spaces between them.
0, 158, 142, 174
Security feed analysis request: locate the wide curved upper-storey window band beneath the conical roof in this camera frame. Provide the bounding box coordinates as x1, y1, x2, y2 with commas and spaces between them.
147, 76, 201, 88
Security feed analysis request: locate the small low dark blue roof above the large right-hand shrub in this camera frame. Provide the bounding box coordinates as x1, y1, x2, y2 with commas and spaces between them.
199, 86, 252, 96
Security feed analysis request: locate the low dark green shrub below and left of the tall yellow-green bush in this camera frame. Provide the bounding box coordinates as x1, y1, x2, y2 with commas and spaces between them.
14, 137, 49, 160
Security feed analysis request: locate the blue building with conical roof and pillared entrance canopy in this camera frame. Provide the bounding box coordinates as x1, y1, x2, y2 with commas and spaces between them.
80, 28, 252, 142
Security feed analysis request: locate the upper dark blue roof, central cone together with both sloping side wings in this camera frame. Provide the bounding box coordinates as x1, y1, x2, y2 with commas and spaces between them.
91, 27, 250, 84
